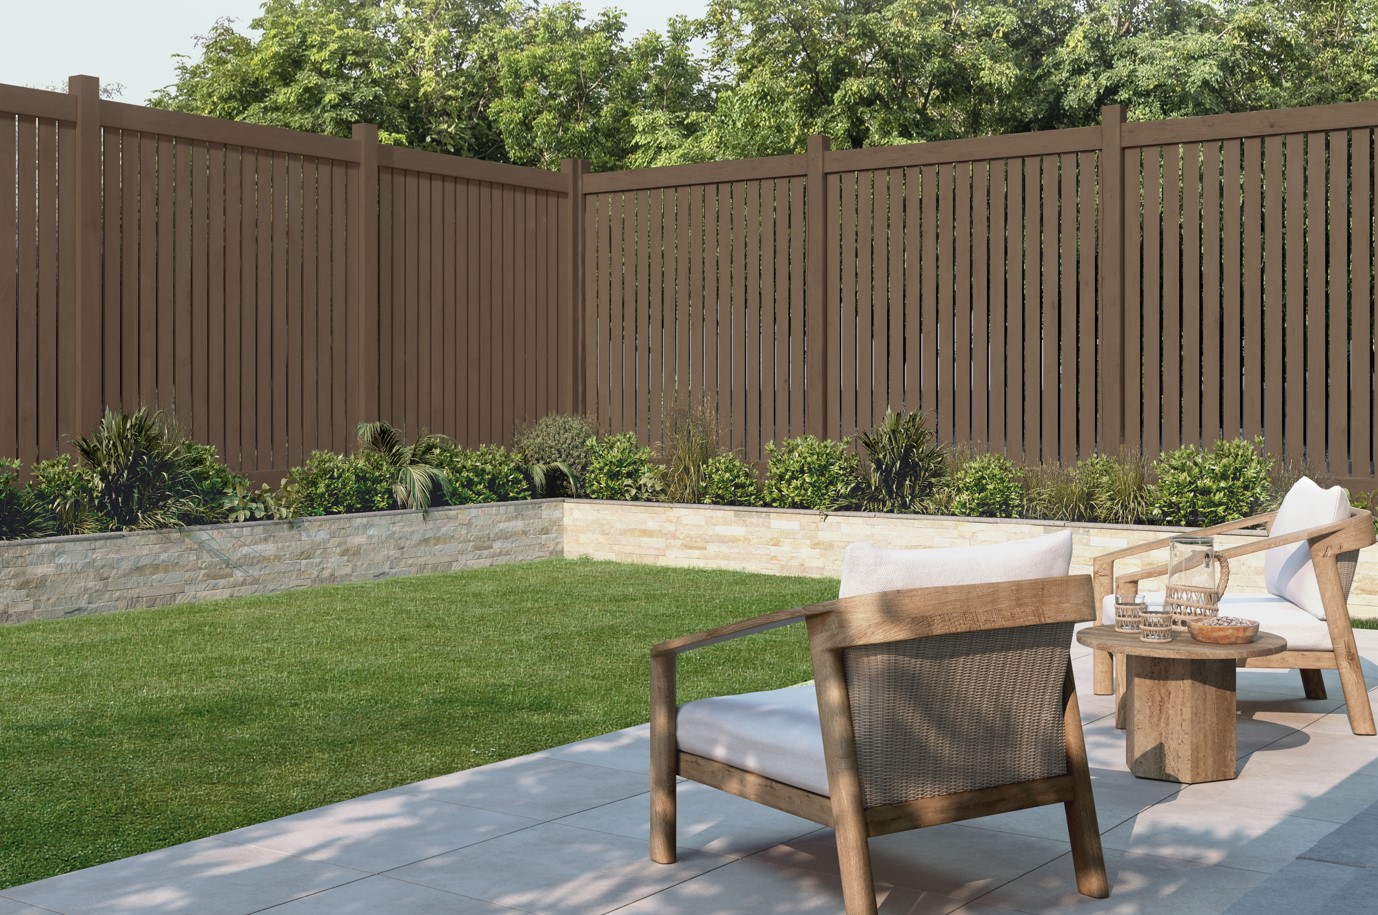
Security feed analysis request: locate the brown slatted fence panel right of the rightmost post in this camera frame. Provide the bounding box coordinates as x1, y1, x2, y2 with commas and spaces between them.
1126, 126, 1375, 488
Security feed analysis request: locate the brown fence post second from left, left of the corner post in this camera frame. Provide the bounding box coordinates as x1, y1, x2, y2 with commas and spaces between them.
347, 124, 379, 429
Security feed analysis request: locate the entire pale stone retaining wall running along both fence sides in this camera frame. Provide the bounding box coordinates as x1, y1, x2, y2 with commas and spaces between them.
8, 499, 1378, 623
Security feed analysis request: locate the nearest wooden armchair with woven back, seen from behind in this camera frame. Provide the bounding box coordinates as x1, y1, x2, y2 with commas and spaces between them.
650, 535, 1109, 915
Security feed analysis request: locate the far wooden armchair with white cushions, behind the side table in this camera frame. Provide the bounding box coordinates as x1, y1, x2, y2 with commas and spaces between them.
1094, 477, 1374, 734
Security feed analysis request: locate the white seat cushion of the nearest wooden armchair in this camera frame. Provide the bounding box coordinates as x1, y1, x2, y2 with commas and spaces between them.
678, 685, 828, 795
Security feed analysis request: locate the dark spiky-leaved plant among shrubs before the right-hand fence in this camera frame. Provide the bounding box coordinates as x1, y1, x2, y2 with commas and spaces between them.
858, 409, 947, 514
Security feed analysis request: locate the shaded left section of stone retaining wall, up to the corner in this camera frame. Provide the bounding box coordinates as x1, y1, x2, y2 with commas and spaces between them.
0, 500, 564, 623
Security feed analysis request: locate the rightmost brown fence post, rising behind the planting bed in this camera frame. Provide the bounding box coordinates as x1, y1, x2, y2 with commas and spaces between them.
1096, 105, 1138, 452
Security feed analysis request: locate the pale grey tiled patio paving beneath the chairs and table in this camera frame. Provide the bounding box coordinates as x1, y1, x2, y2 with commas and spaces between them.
0, 631, 1378, 915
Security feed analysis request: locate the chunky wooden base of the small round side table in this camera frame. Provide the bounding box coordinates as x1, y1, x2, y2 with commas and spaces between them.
1124, 655, 1236, 783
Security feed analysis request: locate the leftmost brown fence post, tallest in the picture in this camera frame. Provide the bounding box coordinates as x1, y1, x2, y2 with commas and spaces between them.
58, 76, 102, 440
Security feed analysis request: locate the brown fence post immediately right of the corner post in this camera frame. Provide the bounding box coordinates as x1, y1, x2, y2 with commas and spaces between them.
803, 135, 838, 440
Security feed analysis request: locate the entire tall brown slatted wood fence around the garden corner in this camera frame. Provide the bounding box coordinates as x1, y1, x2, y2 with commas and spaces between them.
0, 77, 1378, 489
